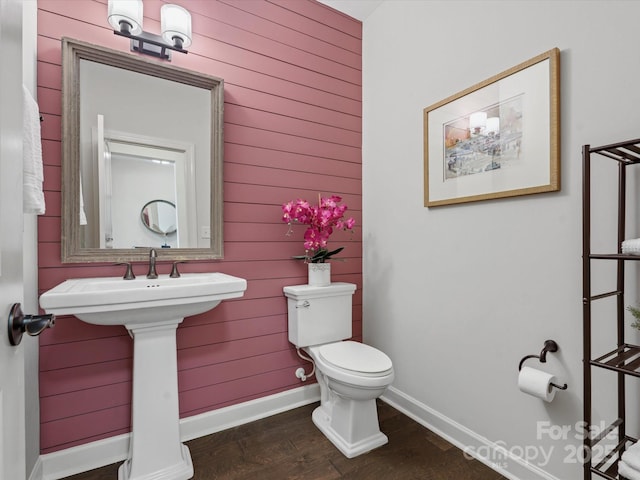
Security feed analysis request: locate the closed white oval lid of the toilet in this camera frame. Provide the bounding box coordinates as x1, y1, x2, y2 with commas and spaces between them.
319, 341, 393, 373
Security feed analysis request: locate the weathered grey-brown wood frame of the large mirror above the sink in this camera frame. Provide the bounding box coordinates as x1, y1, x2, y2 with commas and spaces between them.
61, 38, 224, 263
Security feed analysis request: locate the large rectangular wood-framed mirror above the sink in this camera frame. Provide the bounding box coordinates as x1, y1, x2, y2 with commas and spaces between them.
61, 38, 224, 263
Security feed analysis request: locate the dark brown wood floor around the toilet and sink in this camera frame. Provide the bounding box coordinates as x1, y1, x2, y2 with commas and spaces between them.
68, 401, 504, 480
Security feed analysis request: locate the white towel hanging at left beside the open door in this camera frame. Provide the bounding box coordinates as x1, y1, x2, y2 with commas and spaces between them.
22, 85, 45, 215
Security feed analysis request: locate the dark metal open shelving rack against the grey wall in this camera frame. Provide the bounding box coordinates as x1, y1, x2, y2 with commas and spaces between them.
582, 139, 640, 480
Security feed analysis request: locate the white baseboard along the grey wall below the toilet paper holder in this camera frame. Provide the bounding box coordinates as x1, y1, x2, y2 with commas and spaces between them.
380, 387, 560, 480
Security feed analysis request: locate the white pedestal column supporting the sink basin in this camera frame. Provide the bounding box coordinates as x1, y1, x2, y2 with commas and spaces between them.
118, 318, 193, 480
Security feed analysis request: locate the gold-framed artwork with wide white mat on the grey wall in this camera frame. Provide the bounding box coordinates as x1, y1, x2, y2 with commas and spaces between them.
424, 48, 560, 207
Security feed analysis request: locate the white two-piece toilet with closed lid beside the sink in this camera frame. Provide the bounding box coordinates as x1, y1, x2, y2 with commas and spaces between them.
284, 283, 394, 458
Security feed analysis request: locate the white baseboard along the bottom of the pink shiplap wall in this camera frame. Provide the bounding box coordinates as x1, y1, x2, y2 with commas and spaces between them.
35, 383, 320, 480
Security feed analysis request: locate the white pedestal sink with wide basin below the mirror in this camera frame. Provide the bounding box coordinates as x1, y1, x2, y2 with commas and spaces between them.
40, 273, 247, 480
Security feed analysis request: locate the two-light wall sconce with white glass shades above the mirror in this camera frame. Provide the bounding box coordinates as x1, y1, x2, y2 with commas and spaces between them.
107, 0, 191, 60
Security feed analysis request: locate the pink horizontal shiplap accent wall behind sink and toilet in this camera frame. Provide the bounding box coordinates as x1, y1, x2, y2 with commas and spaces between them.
38, 0, 362, 453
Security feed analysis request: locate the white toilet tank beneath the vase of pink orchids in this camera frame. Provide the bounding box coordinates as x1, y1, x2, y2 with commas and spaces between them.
284, 282, 356, 347
